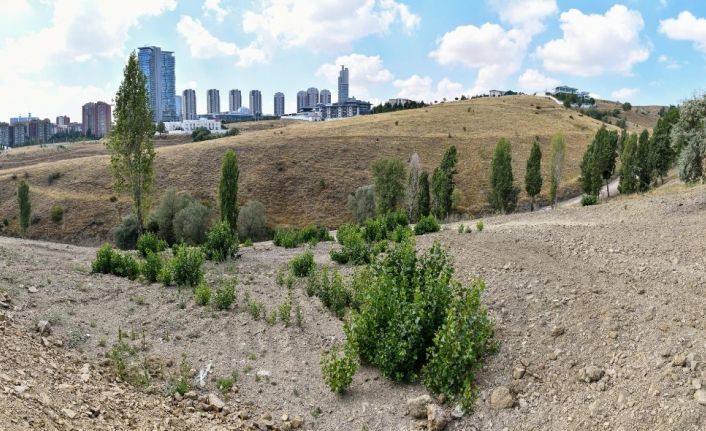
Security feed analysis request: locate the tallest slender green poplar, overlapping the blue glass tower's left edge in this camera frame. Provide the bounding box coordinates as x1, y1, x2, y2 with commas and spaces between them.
107, 52, 155, 235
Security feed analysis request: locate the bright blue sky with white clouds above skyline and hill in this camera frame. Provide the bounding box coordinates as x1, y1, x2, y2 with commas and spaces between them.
0, 0, 706, 121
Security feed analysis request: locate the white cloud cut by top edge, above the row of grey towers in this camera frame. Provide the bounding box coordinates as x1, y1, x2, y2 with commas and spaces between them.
243, 0, 420, 51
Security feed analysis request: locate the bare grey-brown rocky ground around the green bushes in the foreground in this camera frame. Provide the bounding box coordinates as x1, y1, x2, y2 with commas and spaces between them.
0, 187, 706, 431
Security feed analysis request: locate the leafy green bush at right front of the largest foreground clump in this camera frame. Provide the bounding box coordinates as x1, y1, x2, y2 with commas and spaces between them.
423, 280, 497, 411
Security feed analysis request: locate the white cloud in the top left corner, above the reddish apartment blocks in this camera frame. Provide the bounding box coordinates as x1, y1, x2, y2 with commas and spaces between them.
0, 0, 176, 72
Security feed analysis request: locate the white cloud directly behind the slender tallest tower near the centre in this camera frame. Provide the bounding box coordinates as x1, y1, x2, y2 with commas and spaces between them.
316, 54, 393, 101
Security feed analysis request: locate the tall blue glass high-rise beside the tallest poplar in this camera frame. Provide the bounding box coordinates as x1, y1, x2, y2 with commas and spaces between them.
137, 46, 178, 123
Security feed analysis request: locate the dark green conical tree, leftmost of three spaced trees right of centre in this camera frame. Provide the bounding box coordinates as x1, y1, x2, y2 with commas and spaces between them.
488, 138, 519, 213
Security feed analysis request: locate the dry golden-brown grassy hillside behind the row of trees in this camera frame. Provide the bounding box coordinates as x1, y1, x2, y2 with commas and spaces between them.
0, 96, 602, 245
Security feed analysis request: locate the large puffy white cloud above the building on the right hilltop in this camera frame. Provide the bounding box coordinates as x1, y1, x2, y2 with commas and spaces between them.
536, 5, 650, 77
